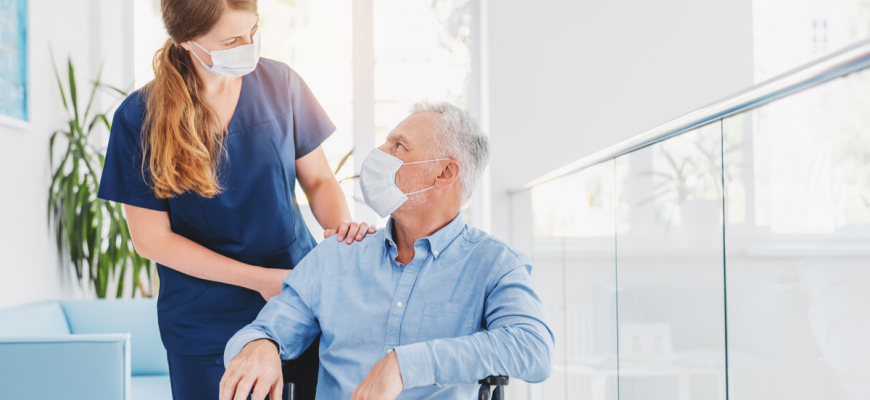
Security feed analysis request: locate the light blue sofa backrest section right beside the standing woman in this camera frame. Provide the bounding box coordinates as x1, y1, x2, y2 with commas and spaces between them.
60, 299, 169, 376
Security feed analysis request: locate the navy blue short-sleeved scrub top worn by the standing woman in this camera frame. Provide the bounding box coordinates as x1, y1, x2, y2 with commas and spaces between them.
98, 59, 335, 355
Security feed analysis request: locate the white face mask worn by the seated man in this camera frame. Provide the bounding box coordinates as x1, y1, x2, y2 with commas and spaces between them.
359, 148, 449, 218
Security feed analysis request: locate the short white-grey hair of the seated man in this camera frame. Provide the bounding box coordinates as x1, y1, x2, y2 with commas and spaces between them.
411, 102, 489, 203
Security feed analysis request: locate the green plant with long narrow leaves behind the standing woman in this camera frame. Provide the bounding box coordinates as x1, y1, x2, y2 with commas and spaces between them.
48, 55, 156, 298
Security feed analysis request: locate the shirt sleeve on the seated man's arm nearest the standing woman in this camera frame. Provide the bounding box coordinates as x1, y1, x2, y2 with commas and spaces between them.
224, 246, 328, 366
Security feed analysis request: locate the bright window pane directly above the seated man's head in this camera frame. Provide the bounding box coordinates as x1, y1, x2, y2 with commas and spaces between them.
374, 0, 471, 143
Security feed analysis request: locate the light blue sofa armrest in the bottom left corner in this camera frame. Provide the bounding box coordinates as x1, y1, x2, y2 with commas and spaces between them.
0, 333, 131, 400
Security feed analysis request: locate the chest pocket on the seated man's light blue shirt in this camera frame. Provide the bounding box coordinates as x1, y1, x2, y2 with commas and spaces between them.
417, 301, 474, 342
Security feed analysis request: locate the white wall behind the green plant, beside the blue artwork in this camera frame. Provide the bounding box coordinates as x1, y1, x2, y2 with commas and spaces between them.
0, 0, 132, 308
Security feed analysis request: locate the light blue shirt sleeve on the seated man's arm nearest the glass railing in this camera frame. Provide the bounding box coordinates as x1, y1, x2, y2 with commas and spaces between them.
396, 266, 554, 389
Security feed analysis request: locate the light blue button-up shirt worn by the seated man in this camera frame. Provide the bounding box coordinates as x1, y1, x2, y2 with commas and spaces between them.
224, 215, 553, 399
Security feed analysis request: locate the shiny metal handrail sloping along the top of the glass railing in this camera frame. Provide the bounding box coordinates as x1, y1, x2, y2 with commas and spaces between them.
511, 39, 870, 193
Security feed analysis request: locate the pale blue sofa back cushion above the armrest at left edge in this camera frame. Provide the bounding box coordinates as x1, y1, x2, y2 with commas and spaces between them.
0, 301, 70, 337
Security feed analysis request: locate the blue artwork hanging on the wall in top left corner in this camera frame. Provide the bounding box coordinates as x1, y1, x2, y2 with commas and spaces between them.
0, 0, 28, 121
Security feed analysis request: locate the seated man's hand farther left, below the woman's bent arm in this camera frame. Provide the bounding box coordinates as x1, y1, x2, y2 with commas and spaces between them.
220, 339, 282, 400
